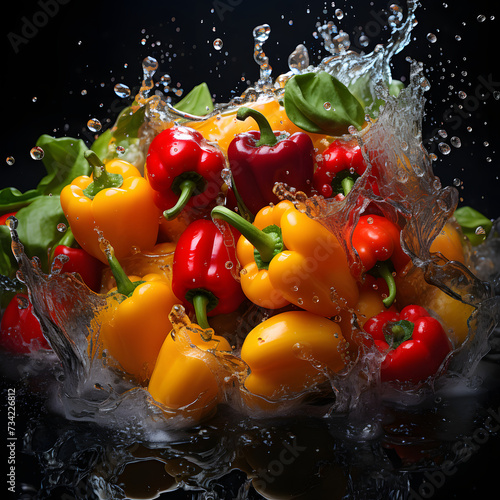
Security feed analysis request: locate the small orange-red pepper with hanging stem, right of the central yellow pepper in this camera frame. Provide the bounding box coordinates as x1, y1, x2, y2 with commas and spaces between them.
352, 214, 410, 307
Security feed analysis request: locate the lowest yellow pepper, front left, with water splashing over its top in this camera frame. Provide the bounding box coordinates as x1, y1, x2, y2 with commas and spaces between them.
148, 305, 231, 422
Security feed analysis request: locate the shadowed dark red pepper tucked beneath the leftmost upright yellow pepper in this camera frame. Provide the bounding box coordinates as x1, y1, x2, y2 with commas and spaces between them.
53, 228, 104, 292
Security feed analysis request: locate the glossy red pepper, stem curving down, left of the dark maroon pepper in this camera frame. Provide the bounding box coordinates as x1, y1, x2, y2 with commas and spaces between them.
146, 126, 226, 219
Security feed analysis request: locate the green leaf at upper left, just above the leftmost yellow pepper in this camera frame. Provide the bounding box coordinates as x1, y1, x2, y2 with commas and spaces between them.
36, 134, 91, 195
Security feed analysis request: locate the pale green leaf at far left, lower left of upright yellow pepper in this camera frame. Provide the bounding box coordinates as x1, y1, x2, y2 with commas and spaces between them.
16, 195, 68, 272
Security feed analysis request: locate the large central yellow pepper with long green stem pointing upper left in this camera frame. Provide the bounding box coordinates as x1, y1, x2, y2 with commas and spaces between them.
212, 201, 359, 317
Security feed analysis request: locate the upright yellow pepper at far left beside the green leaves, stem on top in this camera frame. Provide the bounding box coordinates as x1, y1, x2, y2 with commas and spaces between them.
61, 151, 160, 263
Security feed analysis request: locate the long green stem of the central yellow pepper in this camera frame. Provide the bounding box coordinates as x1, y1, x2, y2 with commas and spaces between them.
212, 206, 283, 264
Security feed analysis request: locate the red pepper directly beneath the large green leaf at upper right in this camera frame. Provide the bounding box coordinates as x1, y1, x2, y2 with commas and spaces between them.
313, 139, 379, 198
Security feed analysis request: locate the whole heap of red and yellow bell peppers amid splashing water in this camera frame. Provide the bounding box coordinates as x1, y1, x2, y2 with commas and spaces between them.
0, 97, 467, 421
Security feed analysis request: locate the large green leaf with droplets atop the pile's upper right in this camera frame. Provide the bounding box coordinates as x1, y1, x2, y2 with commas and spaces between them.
284, 71, 365, 135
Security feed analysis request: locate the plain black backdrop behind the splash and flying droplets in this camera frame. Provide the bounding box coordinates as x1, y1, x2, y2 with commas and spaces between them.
0, 0, 500, 498
